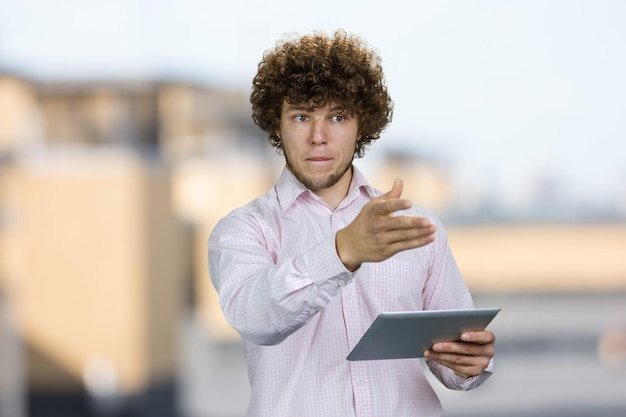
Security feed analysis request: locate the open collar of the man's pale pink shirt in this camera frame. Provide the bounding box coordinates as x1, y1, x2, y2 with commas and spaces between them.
276, 165, 380, 212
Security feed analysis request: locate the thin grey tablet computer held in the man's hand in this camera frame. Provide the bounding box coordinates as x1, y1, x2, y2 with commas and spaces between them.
346, 308, 500, 361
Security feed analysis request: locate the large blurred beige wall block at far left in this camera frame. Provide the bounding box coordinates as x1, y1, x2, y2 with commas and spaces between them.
0, 152, 190, 393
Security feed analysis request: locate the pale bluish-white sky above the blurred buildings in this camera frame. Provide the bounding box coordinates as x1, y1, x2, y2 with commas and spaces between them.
0, 0, 626, 213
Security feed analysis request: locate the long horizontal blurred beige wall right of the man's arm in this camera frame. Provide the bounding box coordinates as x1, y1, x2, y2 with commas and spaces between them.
448, 223, 626, 293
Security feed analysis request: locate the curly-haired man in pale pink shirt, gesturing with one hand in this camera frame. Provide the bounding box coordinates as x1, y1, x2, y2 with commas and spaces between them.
209, 31, 495, 417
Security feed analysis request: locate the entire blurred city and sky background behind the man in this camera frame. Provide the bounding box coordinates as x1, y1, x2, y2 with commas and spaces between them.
0, 0, 626, 417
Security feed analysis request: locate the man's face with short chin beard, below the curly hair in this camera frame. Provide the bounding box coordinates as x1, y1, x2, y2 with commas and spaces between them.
277, 102, 358, 198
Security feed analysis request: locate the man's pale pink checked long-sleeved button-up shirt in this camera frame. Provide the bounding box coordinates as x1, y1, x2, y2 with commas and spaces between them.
209, 168, 492, 417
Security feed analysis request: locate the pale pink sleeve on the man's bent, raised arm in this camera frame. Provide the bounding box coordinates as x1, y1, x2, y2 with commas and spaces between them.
208, 214, 352, 345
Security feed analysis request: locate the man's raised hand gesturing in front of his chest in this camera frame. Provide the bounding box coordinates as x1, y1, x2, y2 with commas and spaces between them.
335, 179, 435, 271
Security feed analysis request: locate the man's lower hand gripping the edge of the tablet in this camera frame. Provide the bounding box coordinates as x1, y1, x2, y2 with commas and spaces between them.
424, 330, 496, 378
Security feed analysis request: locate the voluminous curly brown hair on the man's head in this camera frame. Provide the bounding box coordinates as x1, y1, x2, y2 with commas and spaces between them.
250, 30, 393, 158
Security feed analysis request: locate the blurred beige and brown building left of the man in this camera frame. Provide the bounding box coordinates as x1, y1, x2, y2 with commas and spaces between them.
0, 75, 272, 417
